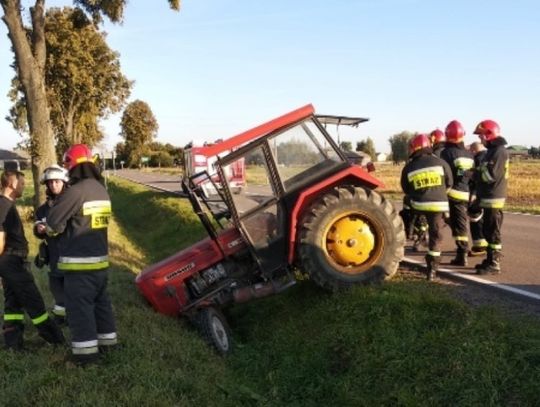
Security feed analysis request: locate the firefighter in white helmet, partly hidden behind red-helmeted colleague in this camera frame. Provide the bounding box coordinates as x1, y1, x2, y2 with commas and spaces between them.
34, 164, 69, 325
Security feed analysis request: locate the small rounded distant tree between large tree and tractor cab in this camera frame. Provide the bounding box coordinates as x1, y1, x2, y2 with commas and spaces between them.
120, 100, 159, 167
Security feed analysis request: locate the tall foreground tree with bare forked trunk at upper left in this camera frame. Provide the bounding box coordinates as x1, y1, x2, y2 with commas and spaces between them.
0, 0, 180, 207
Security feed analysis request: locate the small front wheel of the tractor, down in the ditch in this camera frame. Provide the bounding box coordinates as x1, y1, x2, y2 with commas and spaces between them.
194, 307, 231, 355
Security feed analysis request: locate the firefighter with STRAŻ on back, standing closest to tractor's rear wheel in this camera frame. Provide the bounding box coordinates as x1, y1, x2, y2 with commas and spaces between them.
401, 134, 453, 280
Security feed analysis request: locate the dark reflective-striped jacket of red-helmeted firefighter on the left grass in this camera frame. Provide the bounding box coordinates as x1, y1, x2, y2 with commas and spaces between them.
47, 178, 111, 271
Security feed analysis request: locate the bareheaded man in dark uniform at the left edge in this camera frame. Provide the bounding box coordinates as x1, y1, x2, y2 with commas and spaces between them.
0, 161, 64, 350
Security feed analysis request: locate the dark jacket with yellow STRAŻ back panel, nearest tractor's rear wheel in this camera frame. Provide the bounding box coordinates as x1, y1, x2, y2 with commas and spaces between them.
401, 149, 453, 212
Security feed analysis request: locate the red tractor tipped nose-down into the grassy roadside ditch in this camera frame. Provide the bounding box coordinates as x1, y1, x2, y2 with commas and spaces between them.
136, 105, 405, 353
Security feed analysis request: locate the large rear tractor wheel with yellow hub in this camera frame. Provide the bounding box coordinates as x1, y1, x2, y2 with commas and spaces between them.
298, 186, 405, 290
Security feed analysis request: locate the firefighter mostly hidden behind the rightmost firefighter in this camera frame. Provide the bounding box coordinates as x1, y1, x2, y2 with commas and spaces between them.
468, 141, 487, 256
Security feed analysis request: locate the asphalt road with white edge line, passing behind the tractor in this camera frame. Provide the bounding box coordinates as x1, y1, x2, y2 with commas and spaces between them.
110, 170, 540, 302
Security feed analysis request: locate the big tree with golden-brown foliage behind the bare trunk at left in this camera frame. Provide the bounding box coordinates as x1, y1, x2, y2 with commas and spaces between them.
9, 7, 132, 158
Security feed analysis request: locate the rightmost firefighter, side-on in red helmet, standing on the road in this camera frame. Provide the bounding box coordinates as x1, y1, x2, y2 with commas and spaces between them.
474, 120, 509, 274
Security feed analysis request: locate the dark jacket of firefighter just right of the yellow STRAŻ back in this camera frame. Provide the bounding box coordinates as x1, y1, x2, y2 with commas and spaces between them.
441, 143, 474, 203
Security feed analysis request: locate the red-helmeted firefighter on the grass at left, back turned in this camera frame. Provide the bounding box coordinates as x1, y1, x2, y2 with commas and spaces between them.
46, 144, 117, 365
